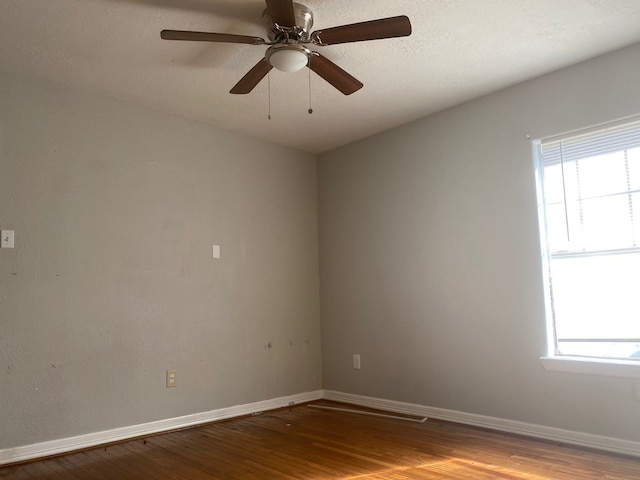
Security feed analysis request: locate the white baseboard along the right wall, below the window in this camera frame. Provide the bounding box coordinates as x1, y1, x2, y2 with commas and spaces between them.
324, 390, 640, 457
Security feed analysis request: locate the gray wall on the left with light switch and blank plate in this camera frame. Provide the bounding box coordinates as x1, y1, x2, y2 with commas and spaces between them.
0, 71, 321, 449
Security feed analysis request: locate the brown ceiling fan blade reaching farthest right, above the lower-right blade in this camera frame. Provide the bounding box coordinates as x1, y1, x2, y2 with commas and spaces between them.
311, 15, 411, 45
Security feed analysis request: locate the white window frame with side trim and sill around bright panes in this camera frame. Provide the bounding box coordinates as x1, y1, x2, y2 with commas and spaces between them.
532, 116, 640, 378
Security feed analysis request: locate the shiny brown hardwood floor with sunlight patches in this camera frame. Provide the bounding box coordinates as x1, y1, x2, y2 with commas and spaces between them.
0, 402, 640, 480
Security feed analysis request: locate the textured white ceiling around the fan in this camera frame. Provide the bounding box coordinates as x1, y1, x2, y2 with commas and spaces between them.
0, 0, 640, 153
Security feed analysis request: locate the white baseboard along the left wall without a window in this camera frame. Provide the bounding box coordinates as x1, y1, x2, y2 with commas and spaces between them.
0, 390, 323, 465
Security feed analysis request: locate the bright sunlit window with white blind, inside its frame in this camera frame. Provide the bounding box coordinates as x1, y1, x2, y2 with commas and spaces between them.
536, 117, 640, 364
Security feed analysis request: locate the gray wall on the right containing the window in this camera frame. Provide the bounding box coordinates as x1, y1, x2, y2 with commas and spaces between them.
318, 46, 640, 440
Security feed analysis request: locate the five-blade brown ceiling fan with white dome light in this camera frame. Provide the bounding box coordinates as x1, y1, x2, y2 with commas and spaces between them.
160, 0, 411, 95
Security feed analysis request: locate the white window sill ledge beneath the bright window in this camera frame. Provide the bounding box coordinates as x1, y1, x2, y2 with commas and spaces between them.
540, 357, 640, 378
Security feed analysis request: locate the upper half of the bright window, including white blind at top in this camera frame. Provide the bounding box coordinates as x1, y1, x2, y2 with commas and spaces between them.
540, 117, 640, 255
